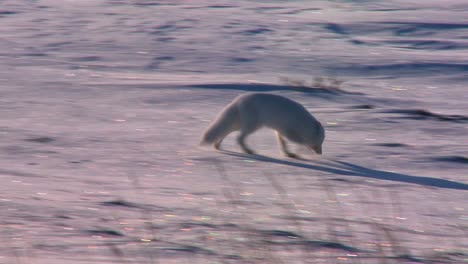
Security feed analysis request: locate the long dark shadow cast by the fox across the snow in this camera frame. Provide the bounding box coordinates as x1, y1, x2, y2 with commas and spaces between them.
221, 150, 468, 190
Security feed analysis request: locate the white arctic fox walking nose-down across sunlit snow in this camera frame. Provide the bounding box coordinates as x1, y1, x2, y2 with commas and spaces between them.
200, 93, 325, 158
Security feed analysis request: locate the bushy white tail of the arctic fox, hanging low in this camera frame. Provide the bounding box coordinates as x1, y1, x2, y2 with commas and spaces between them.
200, 104, 240, 145
